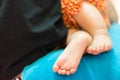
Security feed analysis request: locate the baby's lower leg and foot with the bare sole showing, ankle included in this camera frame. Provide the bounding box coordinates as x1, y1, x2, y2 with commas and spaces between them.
53, 29, 92, 75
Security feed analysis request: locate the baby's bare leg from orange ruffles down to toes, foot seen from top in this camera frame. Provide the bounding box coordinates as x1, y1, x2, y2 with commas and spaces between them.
73, 1, 112, 55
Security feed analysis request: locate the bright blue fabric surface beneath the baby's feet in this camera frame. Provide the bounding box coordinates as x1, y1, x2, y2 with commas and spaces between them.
22, 24, 120, 80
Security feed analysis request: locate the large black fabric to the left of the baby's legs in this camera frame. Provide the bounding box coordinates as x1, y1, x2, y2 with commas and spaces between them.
0, 0, 67, 80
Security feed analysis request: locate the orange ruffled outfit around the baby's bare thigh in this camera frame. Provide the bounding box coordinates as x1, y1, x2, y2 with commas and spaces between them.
61, 0, 110, 28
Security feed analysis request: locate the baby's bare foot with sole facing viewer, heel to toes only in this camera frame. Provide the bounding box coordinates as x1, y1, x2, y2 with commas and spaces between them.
53, 32, 91, 75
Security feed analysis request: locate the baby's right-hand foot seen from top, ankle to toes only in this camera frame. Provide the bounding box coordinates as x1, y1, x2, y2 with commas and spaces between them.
87, 32, 112, 55
